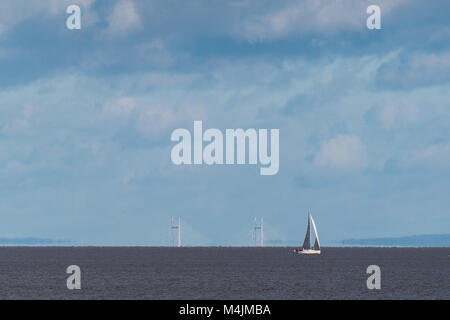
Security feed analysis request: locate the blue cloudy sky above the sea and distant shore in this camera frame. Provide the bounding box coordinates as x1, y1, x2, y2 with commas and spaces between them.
0, 0, 450, 246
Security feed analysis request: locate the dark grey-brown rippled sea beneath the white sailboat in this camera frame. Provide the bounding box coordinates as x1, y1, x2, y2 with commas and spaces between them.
0, 247, 450, 299
